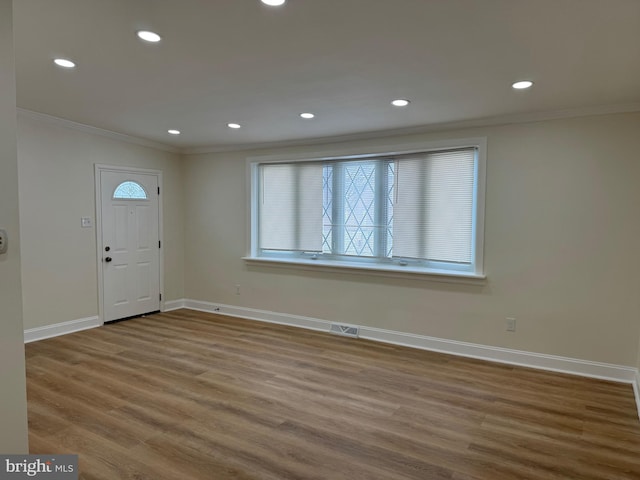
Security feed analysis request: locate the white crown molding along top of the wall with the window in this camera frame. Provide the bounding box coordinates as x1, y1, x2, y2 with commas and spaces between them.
181, 102, 640, 155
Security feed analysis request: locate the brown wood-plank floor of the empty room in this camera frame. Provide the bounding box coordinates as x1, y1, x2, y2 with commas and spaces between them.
26, 310, 640, 480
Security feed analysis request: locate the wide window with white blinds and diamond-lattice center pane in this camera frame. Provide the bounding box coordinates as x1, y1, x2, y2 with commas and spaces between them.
252, 139, 481, 274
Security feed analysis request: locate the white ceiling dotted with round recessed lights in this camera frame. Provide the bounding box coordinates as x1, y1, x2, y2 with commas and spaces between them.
14, 0, 640, 149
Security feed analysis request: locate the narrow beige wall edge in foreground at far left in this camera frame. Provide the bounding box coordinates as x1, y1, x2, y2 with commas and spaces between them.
0, 0, 28, 454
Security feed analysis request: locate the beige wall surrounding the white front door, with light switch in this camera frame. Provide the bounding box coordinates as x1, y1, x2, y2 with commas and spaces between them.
18, 114, 184, 329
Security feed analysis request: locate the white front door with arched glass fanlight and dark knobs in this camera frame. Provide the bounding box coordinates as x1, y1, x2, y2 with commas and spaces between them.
99, 170, 160, 322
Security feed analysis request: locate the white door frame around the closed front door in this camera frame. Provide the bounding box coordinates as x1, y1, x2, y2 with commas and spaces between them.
94, 163, 165, 324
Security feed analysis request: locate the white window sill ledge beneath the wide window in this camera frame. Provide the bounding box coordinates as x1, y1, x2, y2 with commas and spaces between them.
242, 257, 487, 285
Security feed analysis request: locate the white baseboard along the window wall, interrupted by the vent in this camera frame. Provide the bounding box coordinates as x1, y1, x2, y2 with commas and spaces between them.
184, 299, 640, 384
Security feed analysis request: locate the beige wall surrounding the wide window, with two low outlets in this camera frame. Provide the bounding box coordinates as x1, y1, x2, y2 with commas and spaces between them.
184, 114, 640, 366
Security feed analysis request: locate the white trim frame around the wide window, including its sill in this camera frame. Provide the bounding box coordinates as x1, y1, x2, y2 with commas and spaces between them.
243, 137, 487, 283
